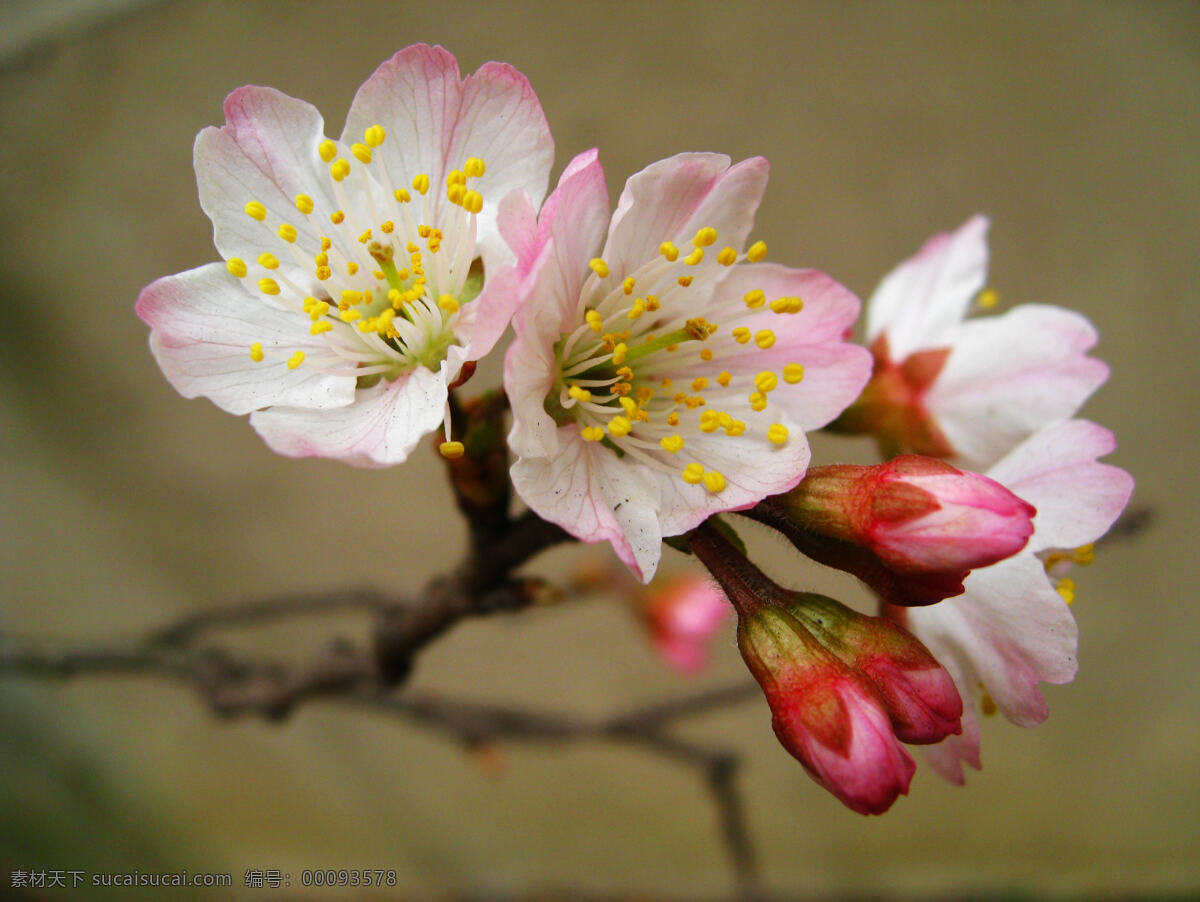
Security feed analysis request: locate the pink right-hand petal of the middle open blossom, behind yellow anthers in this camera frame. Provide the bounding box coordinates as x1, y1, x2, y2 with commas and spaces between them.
709, 264, 871, 429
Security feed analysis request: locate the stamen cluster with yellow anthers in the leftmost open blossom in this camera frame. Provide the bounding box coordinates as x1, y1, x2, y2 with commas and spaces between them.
227, 125, 486, 387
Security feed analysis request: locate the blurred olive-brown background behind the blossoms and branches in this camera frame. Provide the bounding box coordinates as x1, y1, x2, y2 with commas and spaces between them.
0, 0, 1200, 898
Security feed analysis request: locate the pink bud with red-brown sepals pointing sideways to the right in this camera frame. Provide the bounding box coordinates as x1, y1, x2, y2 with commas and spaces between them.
748, 455, 1037, 606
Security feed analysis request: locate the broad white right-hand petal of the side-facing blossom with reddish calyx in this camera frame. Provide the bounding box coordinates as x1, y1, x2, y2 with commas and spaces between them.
925, 303, 1109, 469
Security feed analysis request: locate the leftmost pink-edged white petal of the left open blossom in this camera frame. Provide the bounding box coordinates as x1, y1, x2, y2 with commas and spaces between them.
137, 263, 354, 415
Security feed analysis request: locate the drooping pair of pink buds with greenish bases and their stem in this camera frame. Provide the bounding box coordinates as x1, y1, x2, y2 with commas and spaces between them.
690, 525, 962, 814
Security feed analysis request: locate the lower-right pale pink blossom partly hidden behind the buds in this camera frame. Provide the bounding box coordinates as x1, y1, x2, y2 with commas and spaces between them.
889, 420, 1133, 782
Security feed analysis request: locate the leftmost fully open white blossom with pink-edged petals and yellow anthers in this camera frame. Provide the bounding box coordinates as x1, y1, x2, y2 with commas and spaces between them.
137, 46, 553, 465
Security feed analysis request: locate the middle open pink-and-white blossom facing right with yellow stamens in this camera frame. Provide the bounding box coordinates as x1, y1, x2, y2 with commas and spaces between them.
500, 151, 870, 579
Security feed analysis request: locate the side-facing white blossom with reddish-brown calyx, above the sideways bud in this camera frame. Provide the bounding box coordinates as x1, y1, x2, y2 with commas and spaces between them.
836, 216, 1108, 469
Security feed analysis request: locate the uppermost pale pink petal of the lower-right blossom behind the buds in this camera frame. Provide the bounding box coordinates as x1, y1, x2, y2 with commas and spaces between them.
990, 420, 1134, 552
